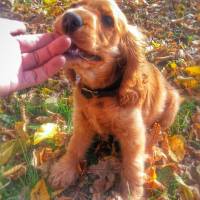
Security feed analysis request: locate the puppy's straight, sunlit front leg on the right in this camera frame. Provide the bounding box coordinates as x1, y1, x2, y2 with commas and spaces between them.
117, 110, 145, 200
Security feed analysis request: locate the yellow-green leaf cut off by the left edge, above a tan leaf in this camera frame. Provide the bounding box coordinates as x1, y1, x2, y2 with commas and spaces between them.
0, 140, 16, 165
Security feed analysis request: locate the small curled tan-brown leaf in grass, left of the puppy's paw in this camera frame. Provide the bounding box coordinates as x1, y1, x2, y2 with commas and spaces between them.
3, 164, 27, 180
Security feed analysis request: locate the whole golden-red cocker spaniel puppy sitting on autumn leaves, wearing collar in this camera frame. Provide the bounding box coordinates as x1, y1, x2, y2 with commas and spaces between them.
49, 0, 180, 200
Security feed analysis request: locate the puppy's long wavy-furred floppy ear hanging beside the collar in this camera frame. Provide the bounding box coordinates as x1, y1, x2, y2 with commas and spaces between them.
118, 25, 145, 106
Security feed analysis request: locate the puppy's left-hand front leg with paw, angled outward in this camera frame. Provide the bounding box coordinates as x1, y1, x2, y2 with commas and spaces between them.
49, 116, 94, 188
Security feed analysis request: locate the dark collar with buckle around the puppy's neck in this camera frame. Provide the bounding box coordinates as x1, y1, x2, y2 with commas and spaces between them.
81, 77, 122, 99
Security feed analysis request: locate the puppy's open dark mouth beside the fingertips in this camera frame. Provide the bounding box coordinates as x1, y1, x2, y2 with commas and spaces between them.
64, 43, 102, 61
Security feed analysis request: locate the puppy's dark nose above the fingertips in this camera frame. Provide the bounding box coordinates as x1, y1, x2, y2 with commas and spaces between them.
62, 12, 83, 33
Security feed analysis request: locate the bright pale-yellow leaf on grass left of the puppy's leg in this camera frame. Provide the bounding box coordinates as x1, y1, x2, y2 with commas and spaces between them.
33, 123, 59, 145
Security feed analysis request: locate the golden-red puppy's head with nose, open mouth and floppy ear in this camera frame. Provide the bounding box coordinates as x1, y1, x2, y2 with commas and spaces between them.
55, 0, 143, 105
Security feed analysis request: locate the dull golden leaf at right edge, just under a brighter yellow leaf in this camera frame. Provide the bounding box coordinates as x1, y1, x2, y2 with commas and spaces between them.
177, 76, 200, 89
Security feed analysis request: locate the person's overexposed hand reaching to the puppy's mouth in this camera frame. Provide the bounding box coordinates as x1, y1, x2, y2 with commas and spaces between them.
0, 19, 71, 96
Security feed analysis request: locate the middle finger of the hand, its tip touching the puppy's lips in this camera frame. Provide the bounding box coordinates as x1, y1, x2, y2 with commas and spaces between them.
22, 36, 71, 70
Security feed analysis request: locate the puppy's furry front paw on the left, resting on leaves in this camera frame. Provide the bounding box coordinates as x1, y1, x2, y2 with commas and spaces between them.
48, 160, 78, 188
